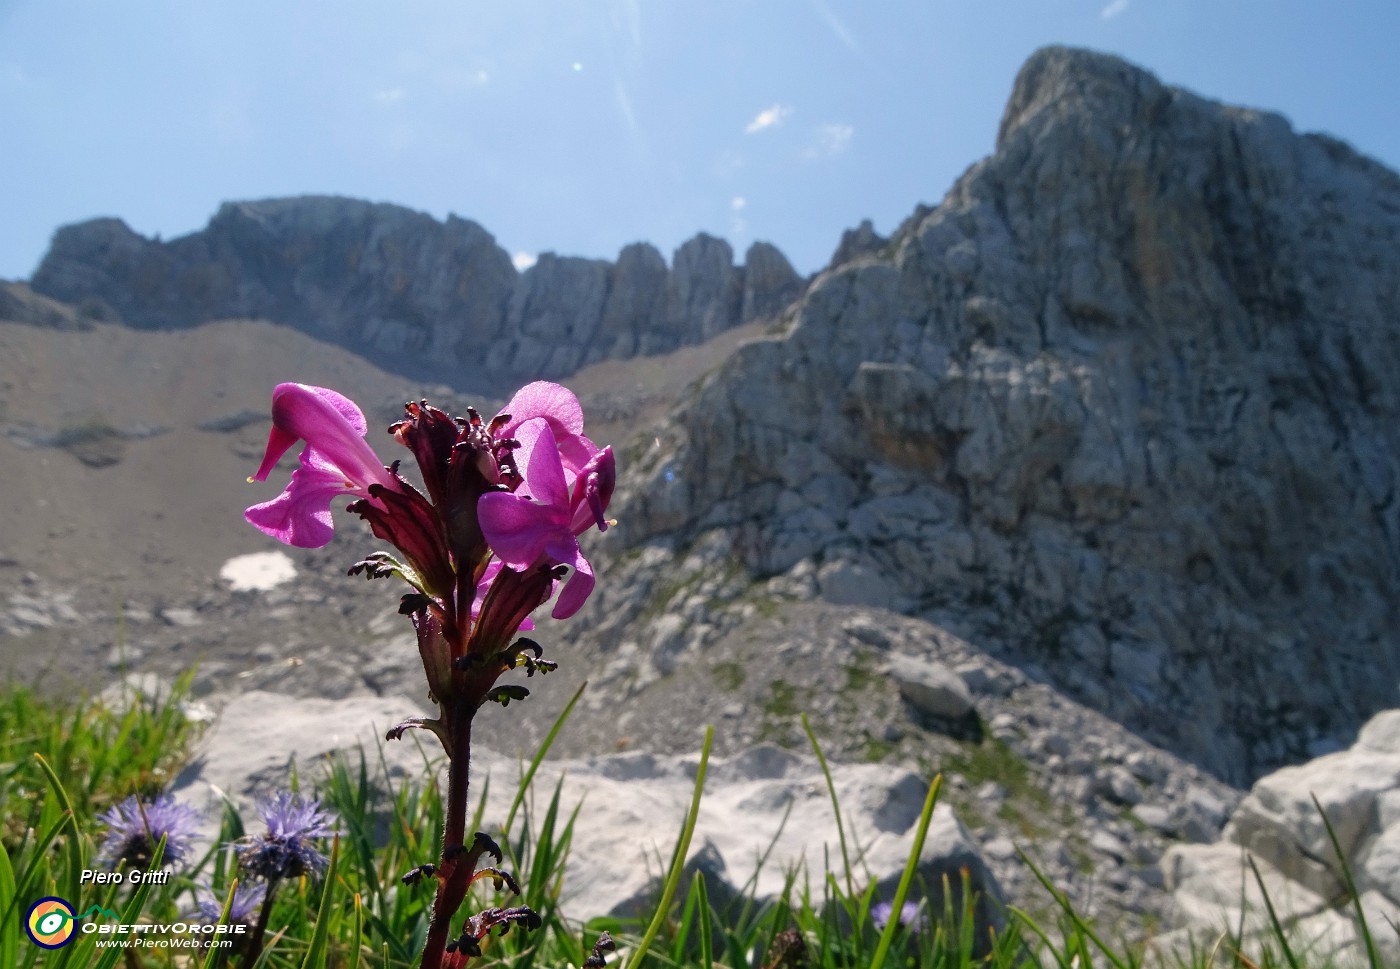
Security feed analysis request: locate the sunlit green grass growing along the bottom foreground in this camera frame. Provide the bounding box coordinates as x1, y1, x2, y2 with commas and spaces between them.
0, 681, 1392, 969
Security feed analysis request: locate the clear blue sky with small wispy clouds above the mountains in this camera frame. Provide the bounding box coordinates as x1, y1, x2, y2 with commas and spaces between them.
0, 0, 1400, 279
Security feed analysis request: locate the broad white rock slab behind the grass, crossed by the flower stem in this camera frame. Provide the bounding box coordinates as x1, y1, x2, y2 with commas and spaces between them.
176, 692, 1001, 924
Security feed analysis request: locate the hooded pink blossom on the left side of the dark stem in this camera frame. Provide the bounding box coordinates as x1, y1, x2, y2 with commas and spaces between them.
244, 384, 400, 549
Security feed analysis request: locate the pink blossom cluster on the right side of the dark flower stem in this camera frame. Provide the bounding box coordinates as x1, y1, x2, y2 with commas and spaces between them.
477, 417, 616, 619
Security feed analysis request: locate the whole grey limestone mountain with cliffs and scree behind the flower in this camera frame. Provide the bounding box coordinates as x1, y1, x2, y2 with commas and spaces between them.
0, 48, 1400, 940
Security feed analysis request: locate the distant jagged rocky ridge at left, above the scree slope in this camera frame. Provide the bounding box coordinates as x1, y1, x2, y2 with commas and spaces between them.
31, 197, 802, 384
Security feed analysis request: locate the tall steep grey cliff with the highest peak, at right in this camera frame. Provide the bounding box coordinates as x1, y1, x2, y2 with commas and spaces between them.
599, 48, 1400, 783
